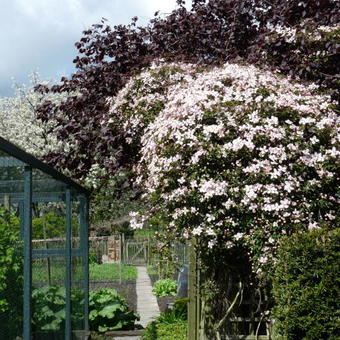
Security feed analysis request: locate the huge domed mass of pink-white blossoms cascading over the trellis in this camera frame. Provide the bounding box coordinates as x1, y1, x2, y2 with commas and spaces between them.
112, 59, 339, 274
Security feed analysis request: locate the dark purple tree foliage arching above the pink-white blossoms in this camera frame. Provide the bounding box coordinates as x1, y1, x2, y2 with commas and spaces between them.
37, 0, 340, 180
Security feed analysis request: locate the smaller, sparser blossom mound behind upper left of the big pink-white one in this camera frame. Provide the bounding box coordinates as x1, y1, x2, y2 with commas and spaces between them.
107, 63, 195, 143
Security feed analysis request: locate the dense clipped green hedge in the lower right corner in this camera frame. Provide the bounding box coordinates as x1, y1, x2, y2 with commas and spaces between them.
273, 229, 340, 340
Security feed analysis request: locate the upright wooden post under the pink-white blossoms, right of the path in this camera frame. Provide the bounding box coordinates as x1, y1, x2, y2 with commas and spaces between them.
188, 238, 199, 340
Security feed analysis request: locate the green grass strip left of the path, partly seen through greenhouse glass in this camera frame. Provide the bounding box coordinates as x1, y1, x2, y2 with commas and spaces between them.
32, 261, 137, 283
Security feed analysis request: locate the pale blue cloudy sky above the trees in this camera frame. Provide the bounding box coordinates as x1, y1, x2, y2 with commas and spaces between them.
0, 0, 189, 97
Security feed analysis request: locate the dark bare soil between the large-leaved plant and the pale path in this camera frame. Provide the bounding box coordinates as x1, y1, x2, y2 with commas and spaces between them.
90, 280, 137, 313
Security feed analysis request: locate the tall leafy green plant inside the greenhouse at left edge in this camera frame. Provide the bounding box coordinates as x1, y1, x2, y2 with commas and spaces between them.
0, 208, 23, 338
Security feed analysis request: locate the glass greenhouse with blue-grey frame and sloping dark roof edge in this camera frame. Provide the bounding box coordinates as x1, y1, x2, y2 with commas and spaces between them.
0, 137, 89, 340
